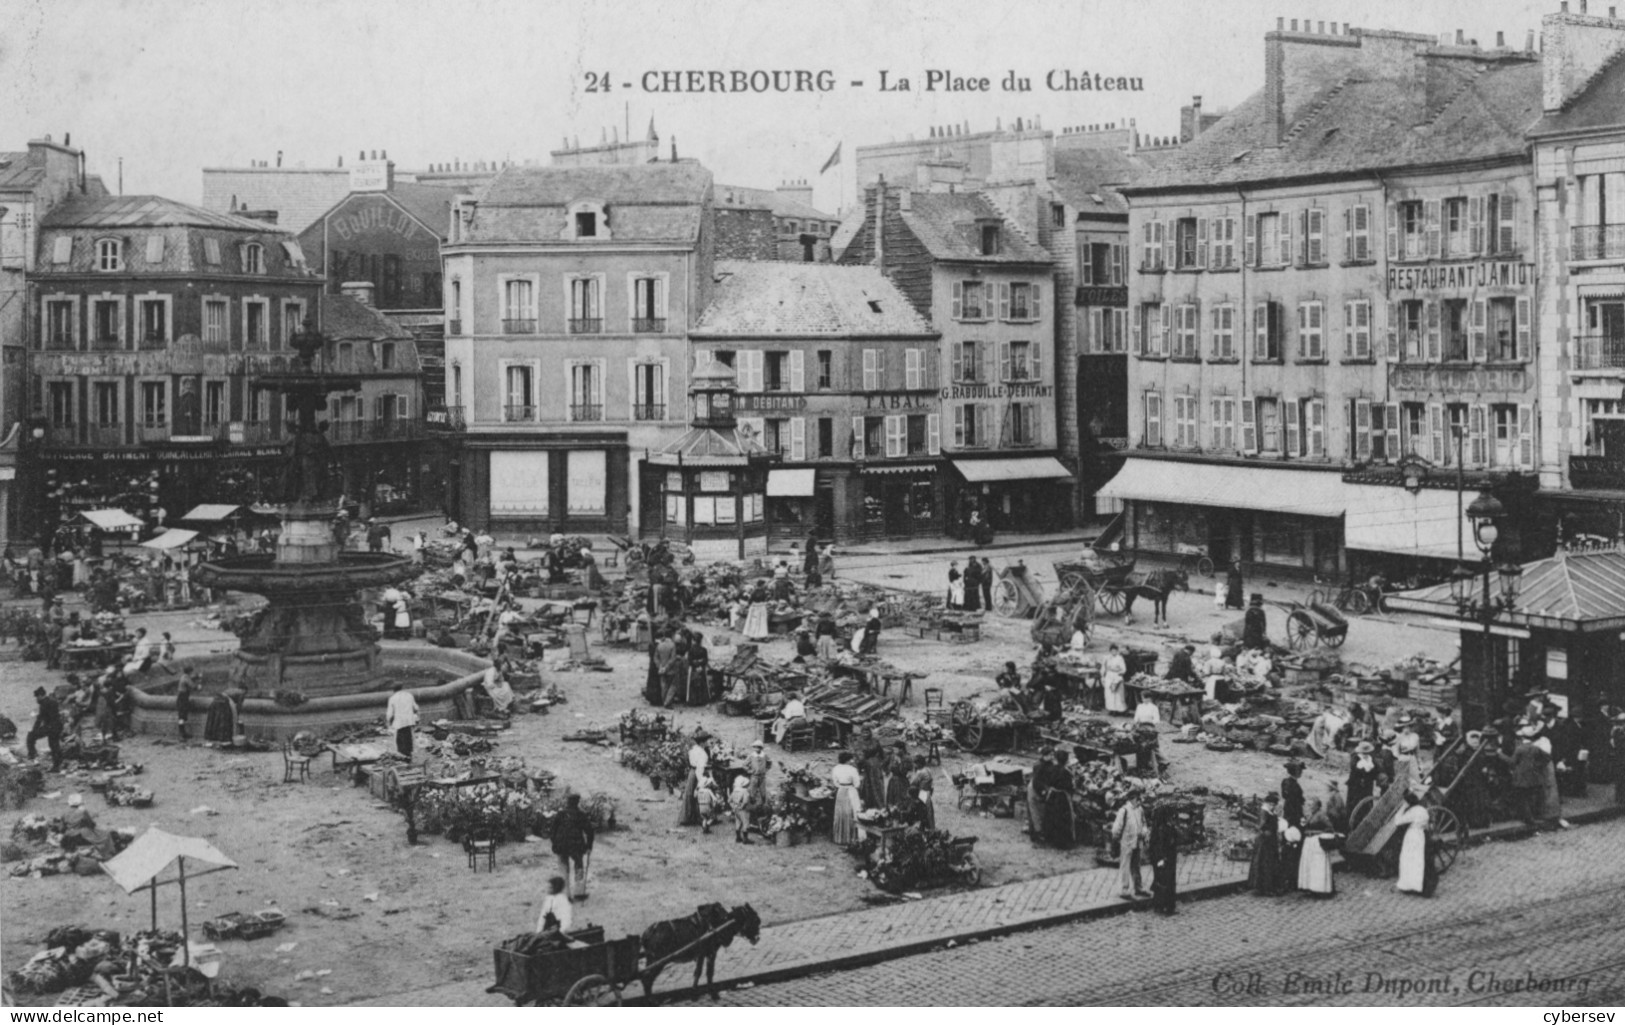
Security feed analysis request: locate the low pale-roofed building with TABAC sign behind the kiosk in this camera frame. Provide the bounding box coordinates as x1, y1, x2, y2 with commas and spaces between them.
682, 260, 944, 541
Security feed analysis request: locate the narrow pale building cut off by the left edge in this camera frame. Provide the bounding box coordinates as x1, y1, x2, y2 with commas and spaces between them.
0, 135, 107, 544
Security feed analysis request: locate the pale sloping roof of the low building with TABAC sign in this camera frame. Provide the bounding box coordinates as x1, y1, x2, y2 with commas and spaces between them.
692, 260, 933, 338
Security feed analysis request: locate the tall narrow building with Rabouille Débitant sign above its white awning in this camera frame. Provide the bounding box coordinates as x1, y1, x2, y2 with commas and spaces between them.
842, 180, 1073, 533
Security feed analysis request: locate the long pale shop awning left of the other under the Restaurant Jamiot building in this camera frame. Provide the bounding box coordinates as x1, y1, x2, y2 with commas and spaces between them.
1095, 456, 1346, 517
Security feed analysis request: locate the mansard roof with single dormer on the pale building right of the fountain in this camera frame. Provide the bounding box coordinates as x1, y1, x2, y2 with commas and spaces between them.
465, 161, 712, 245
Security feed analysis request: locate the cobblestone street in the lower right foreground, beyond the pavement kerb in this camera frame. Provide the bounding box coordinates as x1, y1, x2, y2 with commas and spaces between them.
679, 820, 1625, 1007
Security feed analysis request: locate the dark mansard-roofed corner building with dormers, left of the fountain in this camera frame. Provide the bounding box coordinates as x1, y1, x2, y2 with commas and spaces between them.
28, 197, 322, 528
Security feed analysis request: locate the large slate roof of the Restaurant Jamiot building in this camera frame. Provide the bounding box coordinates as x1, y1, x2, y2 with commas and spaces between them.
1125, 57, 1541, 195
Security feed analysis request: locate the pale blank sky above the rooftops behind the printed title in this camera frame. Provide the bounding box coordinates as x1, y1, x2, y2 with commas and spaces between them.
0, 0, 1547, 213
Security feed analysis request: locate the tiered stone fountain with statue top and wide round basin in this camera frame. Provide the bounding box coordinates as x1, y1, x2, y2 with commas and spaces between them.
127, 322, 489, 737
